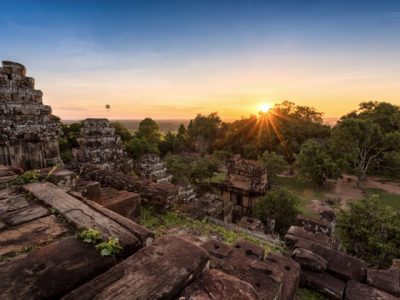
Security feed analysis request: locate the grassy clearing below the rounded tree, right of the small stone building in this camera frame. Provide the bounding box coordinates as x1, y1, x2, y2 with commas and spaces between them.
276, 177, 328, 217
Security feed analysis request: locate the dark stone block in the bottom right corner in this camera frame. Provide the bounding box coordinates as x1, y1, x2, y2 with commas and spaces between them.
344, 280, 399, 300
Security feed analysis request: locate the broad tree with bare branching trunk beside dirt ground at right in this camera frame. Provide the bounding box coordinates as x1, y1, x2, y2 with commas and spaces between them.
331, 118, 400, 184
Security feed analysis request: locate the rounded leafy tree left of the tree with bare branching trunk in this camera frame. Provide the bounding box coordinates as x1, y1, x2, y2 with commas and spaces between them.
297, 140, 341, 186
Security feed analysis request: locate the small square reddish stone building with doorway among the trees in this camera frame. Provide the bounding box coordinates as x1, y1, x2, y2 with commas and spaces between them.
220, 157, 268, 219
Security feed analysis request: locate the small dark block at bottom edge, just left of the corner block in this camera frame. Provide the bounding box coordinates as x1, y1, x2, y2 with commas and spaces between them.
300, 270, 346, 300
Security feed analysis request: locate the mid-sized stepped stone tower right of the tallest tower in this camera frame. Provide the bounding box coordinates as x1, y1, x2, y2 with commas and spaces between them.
73, 119, 133, 174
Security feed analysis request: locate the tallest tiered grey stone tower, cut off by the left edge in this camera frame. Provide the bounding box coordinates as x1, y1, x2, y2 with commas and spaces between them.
0, 61, 62, 170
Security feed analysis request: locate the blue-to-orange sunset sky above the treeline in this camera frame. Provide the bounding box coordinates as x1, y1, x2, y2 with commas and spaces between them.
0, 0, 400, 120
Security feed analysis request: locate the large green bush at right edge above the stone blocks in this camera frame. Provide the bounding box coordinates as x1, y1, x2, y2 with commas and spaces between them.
336, 195, 400, 268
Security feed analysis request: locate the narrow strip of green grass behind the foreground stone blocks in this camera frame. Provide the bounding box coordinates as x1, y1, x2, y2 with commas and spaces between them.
141, 207, 282, 253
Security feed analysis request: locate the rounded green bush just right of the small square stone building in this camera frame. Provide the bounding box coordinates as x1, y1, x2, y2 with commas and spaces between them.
254, 187, 299, 235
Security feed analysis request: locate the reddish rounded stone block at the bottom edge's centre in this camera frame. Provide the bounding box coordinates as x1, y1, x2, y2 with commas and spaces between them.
180, 269, 260, 300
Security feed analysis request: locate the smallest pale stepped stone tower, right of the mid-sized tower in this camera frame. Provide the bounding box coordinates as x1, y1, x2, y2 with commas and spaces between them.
135, 154, 172, 183
